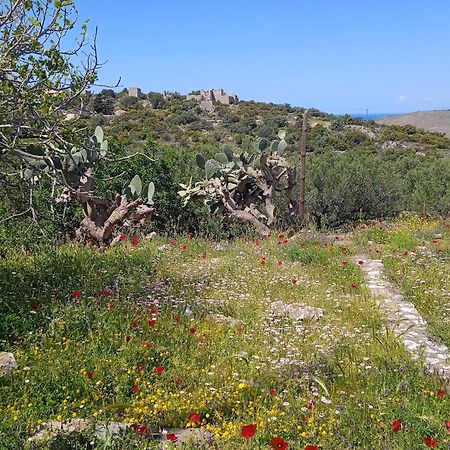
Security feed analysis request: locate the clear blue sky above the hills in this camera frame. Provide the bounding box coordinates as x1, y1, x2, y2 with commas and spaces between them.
75, 0, 450, 113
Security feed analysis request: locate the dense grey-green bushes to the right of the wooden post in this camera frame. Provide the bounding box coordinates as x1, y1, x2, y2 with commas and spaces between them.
306, 152, 450, 227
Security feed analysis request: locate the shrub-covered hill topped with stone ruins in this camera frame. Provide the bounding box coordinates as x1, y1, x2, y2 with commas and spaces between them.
77, 88, 450, 155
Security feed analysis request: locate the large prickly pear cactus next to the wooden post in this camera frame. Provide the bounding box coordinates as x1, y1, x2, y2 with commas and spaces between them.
178, 130, 297, 232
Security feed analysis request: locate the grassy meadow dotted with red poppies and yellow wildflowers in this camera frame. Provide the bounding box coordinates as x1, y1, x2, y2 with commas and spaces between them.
0, 216, 450, 450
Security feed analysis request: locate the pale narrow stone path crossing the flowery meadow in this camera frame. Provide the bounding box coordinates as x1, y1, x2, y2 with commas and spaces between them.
355, 255, 450, 380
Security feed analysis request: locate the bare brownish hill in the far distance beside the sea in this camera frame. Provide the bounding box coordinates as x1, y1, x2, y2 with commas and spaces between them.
376, 110, 450, 137
